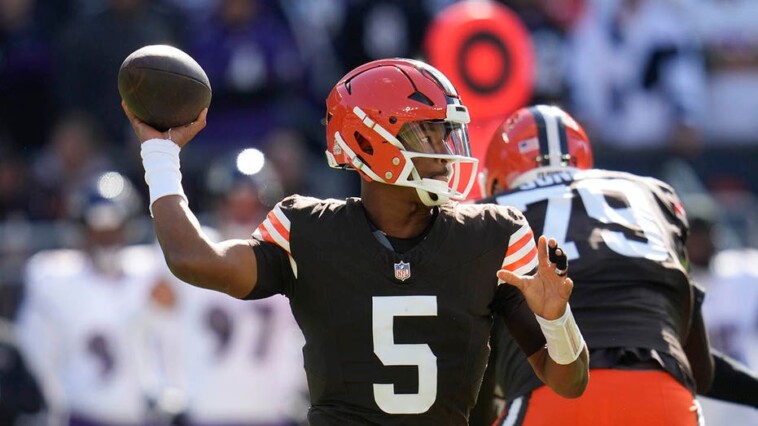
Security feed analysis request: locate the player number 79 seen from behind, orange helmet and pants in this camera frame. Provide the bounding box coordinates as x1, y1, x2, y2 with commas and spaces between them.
480, 105, 758, 426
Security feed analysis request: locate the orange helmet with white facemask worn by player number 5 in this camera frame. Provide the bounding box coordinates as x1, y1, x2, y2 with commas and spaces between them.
326, 58, 478, 206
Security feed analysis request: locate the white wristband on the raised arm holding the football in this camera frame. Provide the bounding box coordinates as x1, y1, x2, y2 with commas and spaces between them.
140, 139, 187, 217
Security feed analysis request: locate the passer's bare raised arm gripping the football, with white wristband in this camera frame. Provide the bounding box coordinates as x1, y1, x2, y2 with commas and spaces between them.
122, 102, 257, 297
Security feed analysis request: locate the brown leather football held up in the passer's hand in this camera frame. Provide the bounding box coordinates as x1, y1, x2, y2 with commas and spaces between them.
118, 44, 212, 132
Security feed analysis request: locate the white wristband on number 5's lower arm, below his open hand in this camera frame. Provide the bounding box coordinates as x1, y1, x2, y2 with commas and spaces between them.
535, 304, 585, 365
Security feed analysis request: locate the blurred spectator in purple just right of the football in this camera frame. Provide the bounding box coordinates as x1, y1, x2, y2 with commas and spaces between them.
188, 0, 318, 151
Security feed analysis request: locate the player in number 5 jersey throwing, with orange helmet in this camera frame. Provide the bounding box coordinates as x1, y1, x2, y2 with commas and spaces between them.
122, 59, 587, 426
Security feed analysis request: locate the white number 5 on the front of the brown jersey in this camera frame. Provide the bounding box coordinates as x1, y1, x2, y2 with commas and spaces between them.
372, 296, 437, 414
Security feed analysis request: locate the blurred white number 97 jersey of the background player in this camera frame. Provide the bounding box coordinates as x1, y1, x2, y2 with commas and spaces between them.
163, 221, 308, 426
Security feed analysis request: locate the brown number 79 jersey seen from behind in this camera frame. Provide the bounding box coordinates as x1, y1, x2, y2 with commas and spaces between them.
481, 170, 693, 398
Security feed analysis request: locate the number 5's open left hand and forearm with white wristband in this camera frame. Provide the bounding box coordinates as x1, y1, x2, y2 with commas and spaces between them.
497, 236, 589, 398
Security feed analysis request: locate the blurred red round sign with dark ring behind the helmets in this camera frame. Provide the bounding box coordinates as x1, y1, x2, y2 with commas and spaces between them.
424, 0, 535, 198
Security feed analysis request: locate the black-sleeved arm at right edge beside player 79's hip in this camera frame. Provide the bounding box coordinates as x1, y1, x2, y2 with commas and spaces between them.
703, 350, 758, 408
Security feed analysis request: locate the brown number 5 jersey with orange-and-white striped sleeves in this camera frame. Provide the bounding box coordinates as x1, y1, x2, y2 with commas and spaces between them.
248, 196, 544, 425
